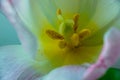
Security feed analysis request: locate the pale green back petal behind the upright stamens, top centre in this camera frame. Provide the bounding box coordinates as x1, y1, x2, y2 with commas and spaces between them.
54, 0, 97, 26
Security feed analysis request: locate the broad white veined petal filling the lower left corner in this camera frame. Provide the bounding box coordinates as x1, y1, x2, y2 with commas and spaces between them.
0, 45, 40, 80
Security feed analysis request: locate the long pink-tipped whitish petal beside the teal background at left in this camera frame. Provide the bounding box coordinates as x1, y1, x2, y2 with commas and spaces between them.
1, 0, 37, 57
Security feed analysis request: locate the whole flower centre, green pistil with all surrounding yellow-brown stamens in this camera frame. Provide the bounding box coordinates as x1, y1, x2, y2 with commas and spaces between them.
46, 9, 91, 49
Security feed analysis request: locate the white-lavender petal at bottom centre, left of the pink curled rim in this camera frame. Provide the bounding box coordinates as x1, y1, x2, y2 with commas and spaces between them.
42, 66, 88, 80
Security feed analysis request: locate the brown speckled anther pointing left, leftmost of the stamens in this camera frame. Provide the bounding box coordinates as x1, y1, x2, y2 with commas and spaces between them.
46, 30, 64, 40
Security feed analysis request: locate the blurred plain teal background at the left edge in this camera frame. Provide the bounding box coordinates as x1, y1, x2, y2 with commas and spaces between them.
0, 13, 19, 46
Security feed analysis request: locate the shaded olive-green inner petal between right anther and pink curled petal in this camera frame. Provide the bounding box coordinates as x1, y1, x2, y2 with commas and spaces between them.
82, 14, 119, 46
